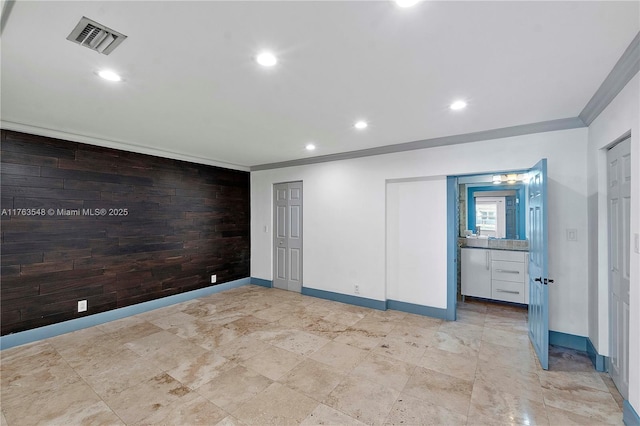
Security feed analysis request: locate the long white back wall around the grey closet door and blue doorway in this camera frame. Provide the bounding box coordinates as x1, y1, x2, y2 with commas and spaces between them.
251, 128, 588, 336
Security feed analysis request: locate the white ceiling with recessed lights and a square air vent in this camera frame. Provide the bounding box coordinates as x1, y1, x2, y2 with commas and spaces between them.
1, 1, 640, 167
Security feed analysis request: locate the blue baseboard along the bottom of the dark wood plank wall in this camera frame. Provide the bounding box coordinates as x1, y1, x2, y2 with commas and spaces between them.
0, 278, 251, 350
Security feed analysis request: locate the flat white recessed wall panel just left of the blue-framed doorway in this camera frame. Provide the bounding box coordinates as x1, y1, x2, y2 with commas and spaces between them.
387, 176, 448, 309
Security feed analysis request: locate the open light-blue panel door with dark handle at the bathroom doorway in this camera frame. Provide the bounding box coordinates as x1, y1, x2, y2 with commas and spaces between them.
527, 158, 549, 370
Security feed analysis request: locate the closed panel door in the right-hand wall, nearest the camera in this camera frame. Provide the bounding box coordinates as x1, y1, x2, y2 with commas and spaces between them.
607, 139, 631, 399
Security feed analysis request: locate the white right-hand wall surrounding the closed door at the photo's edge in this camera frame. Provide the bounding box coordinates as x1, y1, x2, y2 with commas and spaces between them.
588, 74, 640, 412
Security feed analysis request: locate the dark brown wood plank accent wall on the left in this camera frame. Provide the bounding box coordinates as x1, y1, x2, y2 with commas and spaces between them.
0, 130, 250, 335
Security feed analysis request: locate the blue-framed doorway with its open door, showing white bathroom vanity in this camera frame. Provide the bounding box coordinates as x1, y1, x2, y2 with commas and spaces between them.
448, 159, 553, 370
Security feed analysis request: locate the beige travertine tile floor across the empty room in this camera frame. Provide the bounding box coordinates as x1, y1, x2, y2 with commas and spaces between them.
1, 286, 622, 425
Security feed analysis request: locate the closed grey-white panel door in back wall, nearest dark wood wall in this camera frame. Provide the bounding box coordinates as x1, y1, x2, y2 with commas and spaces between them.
273, 182, 302, 293
